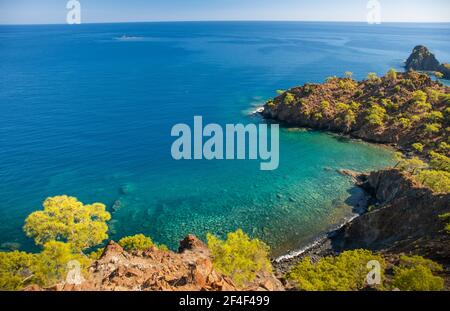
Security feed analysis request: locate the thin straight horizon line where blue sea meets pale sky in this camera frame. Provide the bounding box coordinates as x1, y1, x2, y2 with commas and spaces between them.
0, 19, 450, 26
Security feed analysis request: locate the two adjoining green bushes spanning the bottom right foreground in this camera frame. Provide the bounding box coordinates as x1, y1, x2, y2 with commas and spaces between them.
287, 249, 444, 291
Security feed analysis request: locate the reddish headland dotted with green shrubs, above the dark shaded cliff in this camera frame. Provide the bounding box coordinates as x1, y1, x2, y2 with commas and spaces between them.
263, 69, 450, 193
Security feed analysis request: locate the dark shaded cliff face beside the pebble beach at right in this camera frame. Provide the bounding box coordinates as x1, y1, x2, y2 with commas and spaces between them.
334, 169, 450, 265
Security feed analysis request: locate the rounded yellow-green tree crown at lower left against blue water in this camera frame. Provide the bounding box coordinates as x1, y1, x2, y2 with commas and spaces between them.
24, 195, 111, 252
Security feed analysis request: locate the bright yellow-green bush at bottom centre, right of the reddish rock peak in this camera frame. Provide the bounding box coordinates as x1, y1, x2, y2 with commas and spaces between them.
207, 229, 272, 286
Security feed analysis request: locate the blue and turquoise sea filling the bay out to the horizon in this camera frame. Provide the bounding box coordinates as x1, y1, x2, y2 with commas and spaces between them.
0, 22, 450, 254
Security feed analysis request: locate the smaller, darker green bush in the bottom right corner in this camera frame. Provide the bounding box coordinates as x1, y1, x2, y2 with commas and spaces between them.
392, 256, 444, 291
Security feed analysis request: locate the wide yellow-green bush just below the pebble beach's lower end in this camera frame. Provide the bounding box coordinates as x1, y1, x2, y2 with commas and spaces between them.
287, 250, 386, 291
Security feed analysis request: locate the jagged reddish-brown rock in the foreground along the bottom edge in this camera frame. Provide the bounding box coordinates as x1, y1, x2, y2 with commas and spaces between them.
27, 236, 284, 291
